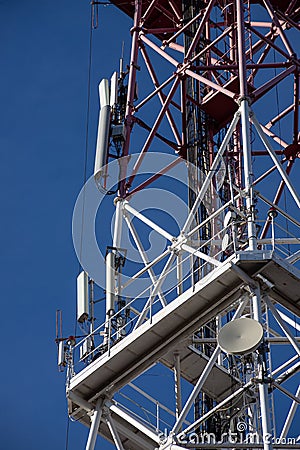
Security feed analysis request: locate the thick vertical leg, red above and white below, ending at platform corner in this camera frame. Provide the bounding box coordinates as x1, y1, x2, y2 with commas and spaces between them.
236, 0, 257, 250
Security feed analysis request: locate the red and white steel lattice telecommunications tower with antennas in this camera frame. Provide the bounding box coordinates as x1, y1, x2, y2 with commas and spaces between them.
59, 0, 300, 450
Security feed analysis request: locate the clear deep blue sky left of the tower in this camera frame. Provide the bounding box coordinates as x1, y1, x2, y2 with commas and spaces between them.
0, 0, 298, 450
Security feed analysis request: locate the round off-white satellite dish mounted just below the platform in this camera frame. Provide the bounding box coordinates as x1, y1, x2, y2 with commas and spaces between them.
218, 317, 263, 355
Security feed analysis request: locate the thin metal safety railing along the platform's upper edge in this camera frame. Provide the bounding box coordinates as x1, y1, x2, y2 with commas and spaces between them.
68, 197, 300, 379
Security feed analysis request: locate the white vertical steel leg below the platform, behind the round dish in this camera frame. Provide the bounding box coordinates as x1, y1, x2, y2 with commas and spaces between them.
252, 287, 273, 450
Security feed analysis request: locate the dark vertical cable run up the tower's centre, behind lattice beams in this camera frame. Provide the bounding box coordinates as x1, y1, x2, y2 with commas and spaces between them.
182, 1, 216, 432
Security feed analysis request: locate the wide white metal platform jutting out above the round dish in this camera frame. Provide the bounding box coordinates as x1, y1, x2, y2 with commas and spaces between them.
67, 252, 300, 410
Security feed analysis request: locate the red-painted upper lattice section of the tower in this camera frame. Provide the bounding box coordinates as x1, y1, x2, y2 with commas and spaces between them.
106, 0, 300, 236
